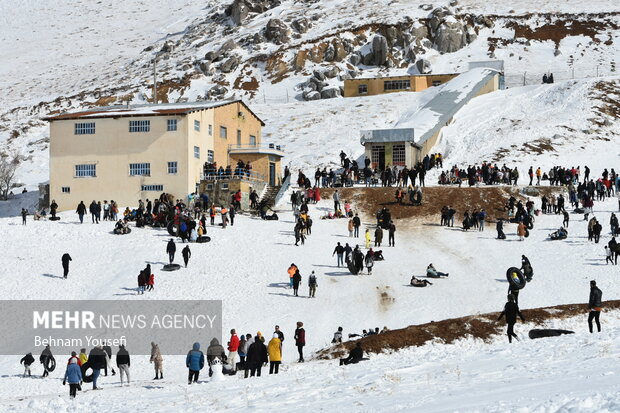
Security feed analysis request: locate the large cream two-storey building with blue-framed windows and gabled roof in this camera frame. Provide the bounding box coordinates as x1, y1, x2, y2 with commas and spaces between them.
45, 100, 284, 210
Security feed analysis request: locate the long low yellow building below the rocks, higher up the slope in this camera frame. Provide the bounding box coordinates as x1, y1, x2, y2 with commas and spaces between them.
344, 73, 458, 98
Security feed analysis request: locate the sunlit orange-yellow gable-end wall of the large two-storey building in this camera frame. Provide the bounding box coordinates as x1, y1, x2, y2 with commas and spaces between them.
213, 102, 262, 167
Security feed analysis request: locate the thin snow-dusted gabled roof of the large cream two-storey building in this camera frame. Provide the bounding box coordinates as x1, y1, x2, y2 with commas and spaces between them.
43, 99, 265, 126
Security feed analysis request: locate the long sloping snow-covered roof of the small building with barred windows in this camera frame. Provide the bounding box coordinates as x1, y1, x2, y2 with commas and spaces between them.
360, 68, 498, 145
